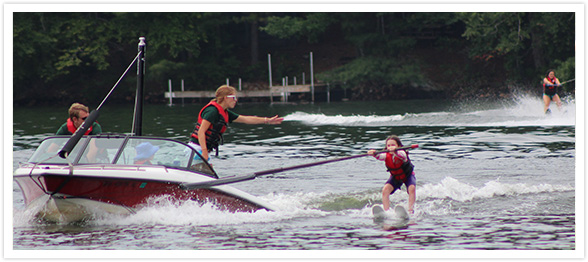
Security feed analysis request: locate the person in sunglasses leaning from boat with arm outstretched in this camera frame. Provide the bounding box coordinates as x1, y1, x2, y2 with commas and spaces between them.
189, 85, 284, 160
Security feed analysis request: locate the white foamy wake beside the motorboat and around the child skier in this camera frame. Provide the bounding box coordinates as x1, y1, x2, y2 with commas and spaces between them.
46, 177, 574, 226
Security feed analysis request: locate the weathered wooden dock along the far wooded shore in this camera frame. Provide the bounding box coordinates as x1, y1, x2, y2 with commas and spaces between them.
164, 84, 328, 104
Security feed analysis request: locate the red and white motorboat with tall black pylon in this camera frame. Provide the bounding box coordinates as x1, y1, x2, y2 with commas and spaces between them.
14, 38, 275, 223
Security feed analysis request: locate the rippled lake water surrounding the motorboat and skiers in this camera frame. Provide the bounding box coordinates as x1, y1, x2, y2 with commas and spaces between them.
5, 93, 583, 259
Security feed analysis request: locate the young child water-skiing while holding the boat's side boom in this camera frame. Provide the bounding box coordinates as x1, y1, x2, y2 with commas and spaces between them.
367, 135, 416, 213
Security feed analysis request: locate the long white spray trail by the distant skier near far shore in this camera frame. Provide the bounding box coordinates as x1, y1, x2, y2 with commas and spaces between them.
284, 95, 576, 127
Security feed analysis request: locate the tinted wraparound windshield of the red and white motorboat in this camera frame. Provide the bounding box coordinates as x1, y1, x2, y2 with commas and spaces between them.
28, 135, 218, 178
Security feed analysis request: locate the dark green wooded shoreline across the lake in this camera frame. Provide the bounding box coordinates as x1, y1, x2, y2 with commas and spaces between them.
13, 12, 576, 105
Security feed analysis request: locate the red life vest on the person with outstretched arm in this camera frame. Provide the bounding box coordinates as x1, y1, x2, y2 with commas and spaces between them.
192, 101, 229, 154
